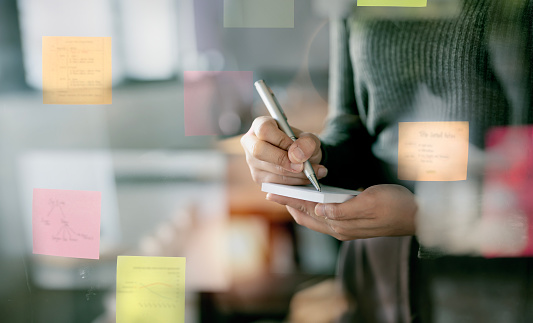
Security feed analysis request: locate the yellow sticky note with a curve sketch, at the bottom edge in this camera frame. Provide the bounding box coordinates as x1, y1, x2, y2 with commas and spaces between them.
116, 256, 185, 323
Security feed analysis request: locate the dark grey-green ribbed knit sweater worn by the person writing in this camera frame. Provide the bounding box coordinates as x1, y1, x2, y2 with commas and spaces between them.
321, 0, 533, 188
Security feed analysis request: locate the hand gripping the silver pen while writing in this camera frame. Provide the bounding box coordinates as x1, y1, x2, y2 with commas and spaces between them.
241, 117, 327, 185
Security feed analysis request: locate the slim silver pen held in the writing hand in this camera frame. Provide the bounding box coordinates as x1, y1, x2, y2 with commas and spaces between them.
254, 80, 322, 192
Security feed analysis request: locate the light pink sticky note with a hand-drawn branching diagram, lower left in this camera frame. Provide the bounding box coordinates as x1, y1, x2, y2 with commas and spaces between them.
32, 188, 101, 259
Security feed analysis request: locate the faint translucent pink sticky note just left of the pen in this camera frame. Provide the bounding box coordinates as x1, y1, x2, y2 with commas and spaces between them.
183, 71, 254, 136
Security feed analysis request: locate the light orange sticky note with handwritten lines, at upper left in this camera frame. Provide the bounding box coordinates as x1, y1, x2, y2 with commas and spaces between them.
42, 36, 111, 104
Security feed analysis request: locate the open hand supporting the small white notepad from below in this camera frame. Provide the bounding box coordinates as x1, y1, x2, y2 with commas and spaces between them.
267, 184, 418, 241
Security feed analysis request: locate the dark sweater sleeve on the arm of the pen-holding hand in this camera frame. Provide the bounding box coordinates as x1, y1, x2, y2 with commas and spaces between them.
320, 20, 380, 189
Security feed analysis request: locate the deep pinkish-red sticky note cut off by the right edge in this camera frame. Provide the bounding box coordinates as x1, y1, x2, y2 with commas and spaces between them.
482, 126, 533, 257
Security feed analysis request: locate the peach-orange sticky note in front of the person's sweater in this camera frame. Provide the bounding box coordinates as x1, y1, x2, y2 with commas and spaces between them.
398, 121, 468, 181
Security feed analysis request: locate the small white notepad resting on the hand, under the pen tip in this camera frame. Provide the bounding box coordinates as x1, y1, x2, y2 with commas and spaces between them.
261, 183, 361, 203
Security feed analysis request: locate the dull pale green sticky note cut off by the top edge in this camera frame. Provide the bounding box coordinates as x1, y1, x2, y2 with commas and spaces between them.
224, 0, 294, 28
